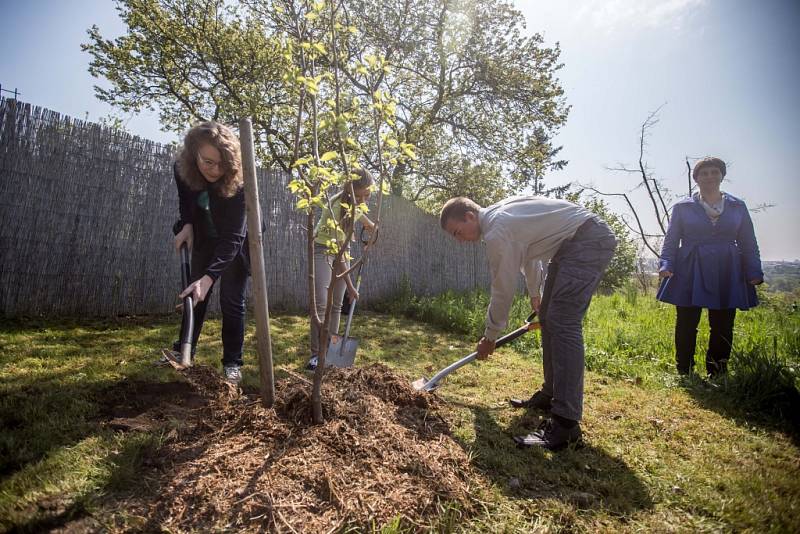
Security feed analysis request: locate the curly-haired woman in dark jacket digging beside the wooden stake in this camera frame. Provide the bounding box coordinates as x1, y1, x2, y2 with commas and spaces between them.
166, 122, 250, 383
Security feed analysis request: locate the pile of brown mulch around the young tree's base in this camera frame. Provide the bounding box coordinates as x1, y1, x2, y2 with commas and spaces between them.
119, 365, 480, 532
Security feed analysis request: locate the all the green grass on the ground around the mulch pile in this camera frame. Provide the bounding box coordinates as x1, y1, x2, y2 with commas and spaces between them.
0, 291, 800, 532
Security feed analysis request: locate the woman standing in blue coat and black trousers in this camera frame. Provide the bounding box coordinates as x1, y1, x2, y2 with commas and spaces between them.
658, 158, 764, 377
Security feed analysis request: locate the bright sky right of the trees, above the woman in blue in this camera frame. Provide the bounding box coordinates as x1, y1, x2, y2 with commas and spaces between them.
516, 0, 800, 259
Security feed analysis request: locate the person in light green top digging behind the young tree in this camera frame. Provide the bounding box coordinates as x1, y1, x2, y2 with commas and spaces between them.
306, 169, 375, 371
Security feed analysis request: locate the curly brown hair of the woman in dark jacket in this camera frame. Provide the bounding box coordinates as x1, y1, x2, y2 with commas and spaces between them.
178, 121, 244, 198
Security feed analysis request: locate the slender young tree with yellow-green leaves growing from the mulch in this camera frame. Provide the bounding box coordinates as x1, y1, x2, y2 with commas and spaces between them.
279, 0, 414, 423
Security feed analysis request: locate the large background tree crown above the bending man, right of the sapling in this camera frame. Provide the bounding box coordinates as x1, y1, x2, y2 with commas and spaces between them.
349, 0, 568, 205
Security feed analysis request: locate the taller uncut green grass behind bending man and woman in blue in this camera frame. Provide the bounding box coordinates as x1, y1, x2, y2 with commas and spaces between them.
375, 285, 800, 396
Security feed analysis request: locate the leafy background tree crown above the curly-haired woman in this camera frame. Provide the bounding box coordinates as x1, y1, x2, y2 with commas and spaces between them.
83, 0, 288, 151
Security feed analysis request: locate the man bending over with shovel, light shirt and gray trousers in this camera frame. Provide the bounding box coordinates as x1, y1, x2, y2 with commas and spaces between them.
440, 196, 616, 450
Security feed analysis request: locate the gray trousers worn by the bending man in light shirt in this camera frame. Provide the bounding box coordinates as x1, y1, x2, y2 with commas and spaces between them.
539, 218, 617, 421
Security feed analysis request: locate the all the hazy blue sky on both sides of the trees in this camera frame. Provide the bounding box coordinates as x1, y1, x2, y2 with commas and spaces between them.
0, 0, 800, 260
